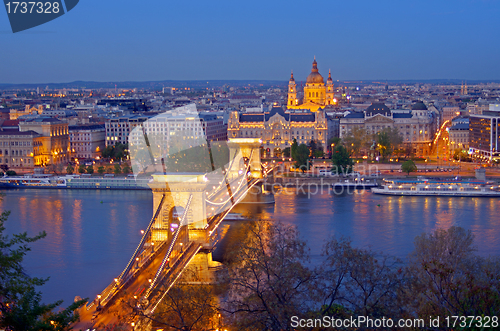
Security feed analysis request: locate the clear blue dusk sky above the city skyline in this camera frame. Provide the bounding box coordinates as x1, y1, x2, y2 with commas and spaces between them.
0, 0, 500, 83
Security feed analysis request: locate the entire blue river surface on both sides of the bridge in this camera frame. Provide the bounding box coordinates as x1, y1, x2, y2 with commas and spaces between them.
0, 189, 500, 306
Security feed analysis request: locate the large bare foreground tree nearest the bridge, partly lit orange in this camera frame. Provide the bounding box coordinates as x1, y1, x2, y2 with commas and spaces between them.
222, 221, 314, 331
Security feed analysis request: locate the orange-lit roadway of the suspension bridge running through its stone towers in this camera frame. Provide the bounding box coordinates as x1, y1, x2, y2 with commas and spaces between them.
74, 178, 261, 330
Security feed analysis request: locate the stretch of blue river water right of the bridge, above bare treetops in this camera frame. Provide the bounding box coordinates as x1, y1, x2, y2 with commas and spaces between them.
246, 191, 500, 258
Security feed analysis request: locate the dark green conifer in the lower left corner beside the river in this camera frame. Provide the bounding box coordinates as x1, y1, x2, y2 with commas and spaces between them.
0, 206, 86, 331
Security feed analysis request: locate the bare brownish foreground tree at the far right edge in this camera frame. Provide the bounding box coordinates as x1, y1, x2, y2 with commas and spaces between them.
405, 226, 500, 316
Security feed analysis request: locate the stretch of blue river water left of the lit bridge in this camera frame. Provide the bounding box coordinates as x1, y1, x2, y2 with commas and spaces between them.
0, 190, 152, 304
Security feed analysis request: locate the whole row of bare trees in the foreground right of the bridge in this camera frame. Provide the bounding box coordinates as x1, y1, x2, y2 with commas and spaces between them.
98, 221, 500, 331
